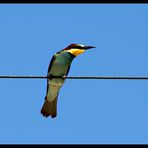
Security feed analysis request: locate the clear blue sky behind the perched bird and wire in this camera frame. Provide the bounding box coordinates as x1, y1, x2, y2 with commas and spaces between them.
0, 4, 148, 144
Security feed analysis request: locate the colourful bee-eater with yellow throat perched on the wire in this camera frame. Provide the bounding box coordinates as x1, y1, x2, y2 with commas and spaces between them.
40, 43, 95, 118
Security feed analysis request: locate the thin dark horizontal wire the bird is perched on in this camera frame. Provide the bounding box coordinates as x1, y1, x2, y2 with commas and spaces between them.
0, 75, 148, 80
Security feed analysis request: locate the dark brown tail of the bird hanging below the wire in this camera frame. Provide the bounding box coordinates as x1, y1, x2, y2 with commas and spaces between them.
41, 97, 57, 118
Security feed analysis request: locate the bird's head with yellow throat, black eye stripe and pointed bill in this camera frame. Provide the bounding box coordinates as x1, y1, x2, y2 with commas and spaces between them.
64, 44, 95, 56
